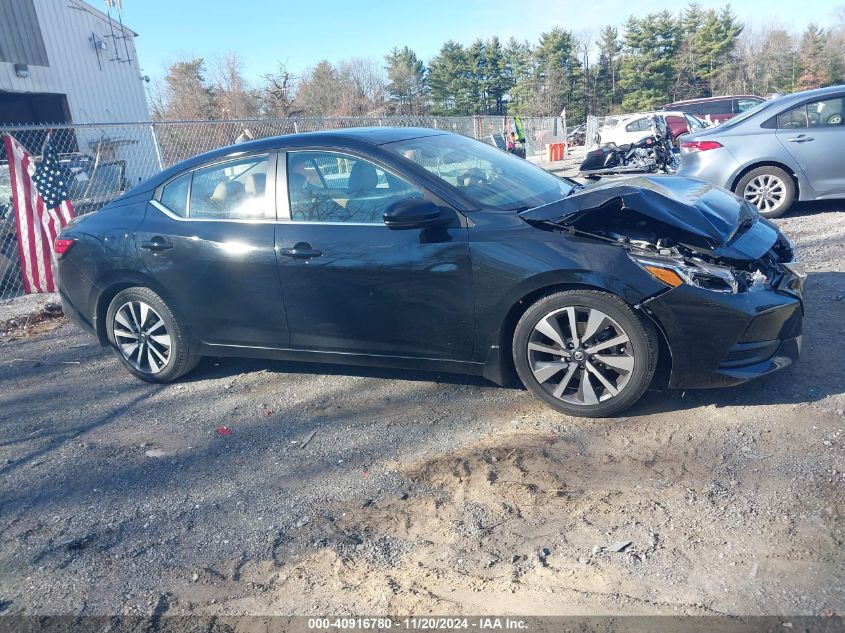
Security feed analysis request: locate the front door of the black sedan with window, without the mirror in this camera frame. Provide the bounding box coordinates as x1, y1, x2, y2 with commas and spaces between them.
276, 145, 473, 360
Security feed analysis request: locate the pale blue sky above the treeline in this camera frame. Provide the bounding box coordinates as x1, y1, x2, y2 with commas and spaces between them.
120, 0, 845, 81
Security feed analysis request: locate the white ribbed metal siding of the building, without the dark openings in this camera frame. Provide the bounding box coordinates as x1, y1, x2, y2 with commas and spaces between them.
0, 0, 149, 123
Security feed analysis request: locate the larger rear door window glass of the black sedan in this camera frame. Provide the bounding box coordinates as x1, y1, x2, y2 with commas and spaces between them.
190, 156, 275, 220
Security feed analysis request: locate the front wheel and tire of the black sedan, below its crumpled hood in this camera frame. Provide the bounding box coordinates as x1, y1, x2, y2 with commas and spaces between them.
513, 290, 658, 417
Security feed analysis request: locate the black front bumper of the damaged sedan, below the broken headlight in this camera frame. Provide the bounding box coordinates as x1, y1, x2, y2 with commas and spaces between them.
643, 278, 804, 389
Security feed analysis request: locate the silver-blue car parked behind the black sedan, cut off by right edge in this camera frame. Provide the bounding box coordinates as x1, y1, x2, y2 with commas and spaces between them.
678, 86, 845, 218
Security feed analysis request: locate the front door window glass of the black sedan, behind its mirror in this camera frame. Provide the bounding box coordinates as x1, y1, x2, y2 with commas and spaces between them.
287, 151, 423, 224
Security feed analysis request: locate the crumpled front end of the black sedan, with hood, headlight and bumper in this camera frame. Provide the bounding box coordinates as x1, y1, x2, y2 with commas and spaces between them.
521, 176, 806, 388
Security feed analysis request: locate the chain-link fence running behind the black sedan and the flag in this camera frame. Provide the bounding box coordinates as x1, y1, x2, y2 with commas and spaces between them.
0, 116, 566, 336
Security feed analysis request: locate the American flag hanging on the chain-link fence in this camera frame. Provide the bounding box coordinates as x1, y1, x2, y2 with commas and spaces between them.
3, 134, 73, 293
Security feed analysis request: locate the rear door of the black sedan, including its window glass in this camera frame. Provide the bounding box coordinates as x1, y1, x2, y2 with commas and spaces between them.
136, 152, 288, 347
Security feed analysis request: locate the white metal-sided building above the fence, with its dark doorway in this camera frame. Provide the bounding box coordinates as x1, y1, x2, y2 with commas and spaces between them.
0, 0, 149, 125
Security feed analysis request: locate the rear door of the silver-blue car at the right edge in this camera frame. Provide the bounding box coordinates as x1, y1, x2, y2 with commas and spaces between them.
776, 94, 845, 197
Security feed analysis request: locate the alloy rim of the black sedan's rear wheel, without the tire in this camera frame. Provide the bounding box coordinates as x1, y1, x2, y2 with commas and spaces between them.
112, 301, 172, 374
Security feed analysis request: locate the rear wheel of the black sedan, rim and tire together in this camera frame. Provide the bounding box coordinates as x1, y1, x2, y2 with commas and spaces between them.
106, 286, 201, 383
